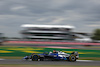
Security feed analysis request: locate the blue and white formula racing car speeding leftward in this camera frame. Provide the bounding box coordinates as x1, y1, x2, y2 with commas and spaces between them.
23, 51, 79, 62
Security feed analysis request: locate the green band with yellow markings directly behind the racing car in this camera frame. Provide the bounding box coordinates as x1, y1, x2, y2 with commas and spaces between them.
0, 47, 100, 58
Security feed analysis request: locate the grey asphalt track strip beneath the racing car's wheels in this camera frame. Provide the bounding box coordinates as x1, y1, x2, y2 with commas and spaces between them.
0, 59, 100, 66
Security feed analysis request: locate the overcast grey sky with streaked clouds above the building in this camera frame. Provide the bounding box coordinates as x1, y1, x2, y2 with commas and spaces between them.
0, 0, 100, 37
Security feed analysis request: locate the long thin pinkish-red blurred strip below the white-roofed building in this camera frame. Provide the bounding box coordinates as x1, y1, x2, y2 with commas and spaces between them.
7, 41, 100, 45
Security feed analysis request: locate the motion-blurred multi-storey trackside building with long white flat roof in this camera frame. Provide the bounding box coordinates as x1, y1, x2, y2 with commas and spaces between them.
21, 24, 74, 40
